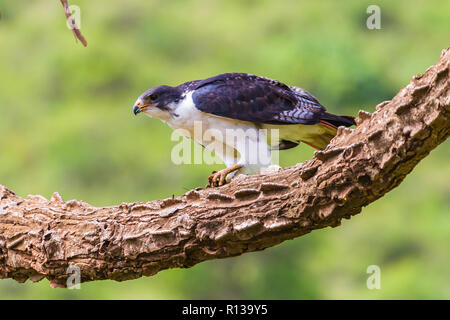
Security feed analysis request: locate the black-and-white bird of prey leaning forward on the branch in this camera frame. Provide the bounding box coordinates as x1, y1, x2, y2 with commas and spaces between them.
133, 73, 355, 186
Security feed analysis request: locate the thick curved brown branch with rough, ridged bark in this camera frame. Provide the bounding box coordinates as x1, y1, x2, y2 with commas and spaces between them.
0, 49, 450, 286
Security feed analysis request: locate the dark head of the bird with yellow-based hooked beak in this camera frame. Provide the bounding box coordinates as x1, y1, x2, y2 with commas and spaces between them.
133, 86, 181, 117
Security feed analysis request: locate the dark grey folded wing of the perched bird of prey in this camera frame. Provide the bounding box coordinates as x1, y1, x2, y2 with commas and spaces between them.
192, 73, 325, 124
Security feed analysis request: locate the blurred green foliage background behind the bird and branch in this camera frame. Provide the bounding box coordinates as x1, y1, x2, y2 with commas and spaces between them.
0, 0, 450, 299
